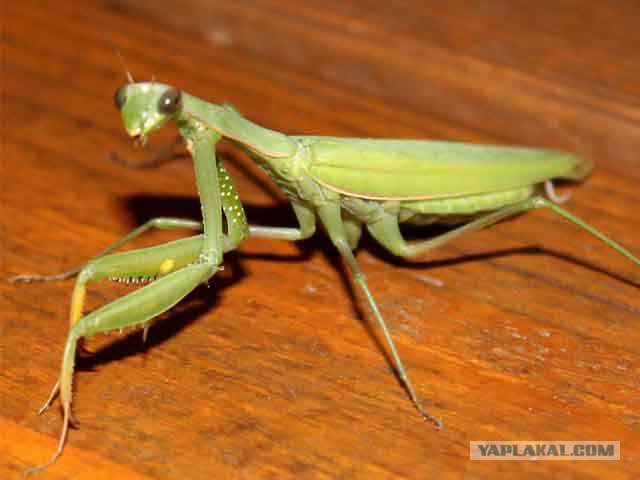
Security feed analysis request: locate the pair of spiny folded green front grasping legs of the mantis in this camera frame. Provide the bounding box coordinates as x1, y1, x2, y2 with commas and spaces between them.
27, 130, 231, 474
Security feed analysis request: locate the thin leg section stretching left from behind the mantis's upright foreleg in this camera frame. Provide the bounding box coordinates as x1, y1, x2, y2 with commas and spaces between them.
9, 217, 202, 282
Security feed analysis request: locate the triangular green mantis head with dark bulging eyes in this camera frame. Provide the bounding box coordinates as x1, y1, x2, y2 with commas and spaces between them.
114, 82, 182, 145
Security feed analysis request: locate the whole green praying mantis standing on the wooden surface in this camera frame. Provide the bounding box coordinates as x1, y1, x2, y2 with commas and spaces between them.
17, 78, 640, 473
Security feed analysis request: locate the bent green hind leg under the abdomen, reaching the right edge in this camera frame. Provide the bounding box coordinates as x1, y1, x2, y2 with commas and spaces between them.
367, 196, 640, 265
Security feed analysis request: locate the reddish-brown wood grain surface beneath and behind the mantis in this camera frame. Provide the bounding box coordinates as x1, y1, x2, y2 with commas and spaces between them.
0, 0, 640, 479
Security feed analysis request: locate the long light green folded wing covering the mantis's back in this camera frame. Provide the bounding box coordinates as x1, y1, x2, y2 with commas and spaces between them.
297, 137, 592, 200
